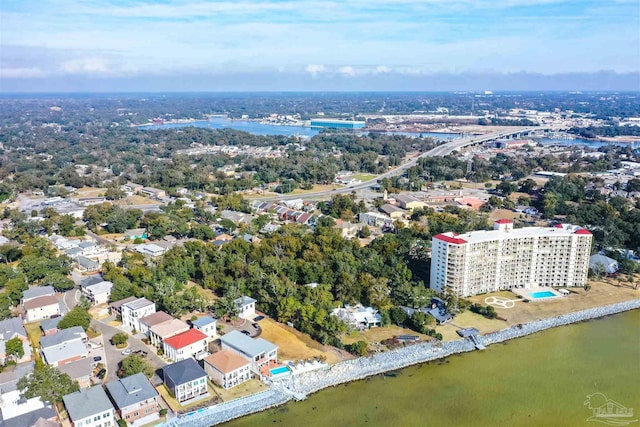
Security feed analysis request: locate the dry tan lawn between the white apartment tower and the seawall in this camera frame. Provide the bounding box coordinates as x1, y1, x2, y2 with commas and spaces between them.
464, 276, 640, 329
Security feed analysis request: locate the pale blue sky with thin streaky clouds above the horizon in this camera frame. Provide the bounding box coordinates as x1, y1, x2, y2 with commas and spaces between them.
0, 0, 640, 92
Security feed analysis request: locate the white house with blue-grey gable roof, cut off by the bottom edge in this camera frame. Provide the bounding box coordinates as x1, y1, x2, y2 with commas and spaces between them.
62, 385, 117, 427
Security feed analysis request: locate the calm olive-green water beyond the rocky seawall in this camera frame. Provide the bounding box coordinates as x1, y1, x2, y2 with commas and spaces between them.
225, 310, 640, 427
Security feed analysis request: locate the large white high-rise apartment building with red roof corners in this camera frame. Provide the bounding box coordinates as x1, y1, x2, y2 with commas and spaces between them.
431, 219, 592, 297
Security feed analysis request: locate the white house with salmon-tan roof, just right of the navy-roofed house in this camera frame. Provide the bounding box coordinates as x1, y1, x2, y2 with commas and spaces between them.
204, 350, 252, 390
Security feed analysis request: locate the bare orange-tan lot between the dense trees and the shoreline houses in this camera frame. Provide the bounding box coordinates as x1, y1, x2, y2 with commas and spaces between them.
260, 318, 340, 363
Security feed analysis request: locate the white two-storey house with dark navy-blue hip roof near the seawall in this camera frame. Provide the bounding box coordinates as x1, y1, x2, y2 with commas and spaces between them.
162, 359, 209, 404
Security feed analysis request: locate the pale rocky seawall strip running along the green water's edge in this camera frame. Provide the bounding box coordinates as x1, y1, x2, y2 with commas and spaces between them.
163, 299, 640, 427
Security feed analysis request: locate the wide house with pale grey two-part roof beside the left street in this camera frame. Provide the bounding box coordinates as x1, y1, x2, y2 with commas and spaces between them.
40, 326, 89, 367
